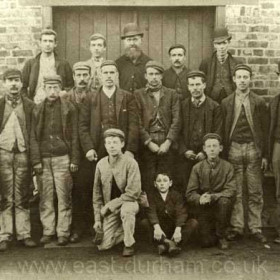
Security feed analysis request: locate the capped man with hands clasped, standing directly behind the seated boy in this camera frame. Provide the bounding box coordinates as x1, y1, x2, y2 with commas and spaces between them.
135, 60, 180, 192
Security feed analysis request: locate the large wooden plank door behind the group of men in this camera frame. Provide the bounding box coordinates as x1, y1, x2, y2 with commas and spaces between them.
53, 6, 215, 69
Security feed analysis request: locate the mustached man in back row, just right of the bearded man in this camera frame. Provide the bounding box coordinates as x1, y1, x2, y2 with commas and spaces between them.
162, 44, 190, 100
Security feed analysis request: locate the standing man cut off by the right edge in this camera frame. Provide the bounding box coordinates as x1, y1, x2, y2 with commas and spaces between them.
268, 62, 280, 244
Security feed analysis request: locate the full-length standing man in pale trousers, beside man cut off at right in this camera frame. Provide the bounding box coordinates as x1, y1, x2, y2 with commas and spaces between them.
221, 64, 269, 243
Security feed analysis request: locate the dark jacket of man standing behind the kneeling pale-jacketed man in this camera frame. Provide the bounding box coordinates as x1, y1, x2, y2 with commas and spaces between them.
79, 87, 139, 154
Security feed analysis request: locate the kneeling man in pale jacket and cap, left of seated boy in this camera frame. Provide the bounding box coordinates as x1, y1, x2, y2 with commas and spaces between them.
92, 128, 141, 256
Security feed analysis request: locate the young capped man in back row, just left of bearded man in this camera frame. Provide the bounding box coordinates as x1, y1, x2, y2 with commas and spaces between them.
86, 33, 106, 90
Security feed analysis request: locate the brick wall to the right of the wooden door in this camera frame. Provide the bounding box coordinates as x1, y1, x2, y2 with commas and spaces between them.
226, 0, 280, 95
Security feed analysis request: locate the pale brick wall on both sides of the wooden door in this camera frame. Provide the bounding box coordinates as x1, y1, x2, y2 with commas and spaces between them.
0, 0, 280, 95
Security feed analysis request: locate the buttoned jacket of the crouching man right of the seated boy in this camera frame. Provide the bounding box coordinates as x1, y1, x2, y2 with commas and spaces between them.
186, 159, 236, 205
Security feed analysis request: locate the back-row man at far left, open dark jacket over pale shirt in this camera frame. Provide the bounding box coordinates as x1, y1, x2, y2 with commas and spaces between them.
22, 28, 74, 104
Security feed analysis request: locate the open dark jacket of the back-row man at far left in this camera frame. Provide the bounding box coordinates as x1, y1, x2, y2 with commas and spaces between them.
22, 53, 74, 100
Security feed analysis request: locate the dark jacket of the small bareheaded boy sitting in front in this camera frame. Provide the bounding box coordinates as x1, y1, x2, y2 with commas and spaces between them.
147, 189, 188, 227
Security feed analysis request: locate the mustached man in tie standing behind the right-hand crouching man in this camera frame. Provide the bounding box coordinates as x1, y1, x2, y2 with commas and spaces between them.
179, 71, 223, 193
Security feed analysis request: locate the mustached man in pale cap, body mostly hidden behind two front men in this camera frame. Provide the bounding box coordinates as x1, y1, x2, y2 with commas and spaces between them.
63, 62, 93, 243
